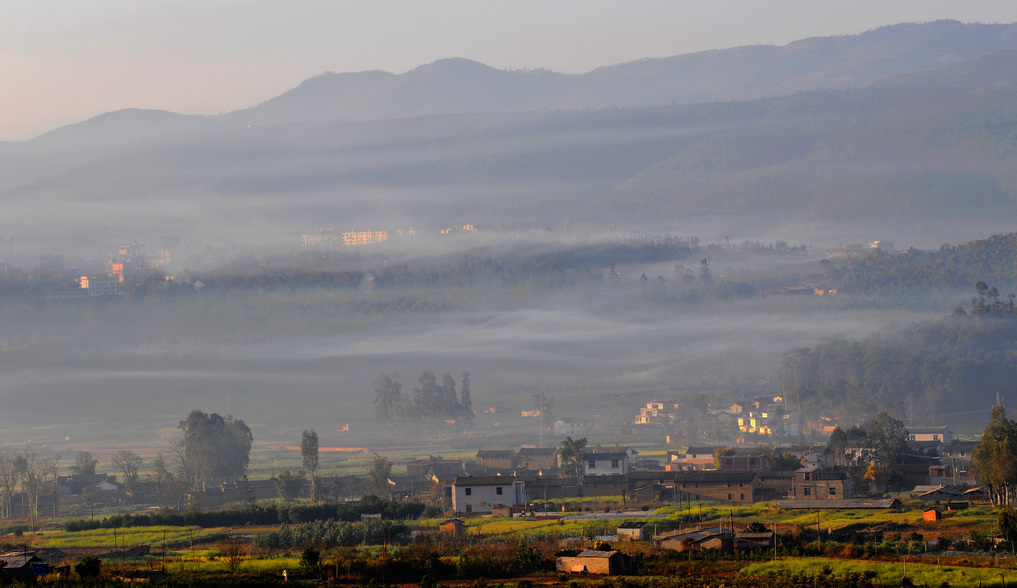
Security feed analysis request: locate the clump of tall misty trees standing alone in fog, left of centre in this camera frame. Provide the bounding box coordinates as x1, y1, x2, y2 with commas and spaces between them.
374, 369, 474, 434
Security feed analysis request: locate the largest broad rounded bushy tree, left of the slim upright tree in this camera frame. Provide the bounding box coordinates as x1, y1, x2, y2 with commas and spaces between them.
175, 410, 254, 490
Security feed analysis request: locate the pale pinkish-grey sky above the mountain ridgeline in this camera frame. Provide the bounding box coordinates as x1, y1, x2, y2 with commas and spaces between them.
0, 0, 1017, 141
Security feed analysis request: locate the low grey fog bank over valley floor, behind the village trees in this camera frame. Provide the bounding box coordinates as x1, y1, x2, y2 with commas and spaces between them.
0, 286, 944, 453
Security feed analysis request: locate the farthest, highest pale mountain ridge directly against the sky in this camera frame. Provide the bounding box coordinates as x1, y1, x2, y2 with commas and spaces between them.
222, 20, 1017, 126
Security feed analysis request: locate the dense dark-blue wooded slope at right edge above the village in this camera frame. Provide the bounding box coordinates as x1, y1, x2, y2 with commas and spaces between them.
779, 284, 1017, 424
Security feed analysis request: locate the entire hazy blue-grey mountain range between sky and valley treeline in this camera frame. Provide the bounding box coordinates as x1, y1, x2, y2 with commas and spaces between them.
0, 21, 1017, 239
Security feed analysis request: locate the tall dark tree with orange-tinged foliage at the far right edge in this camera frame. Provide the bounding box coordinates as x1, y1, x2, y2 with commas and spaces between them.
971, 406, 1017, 506
